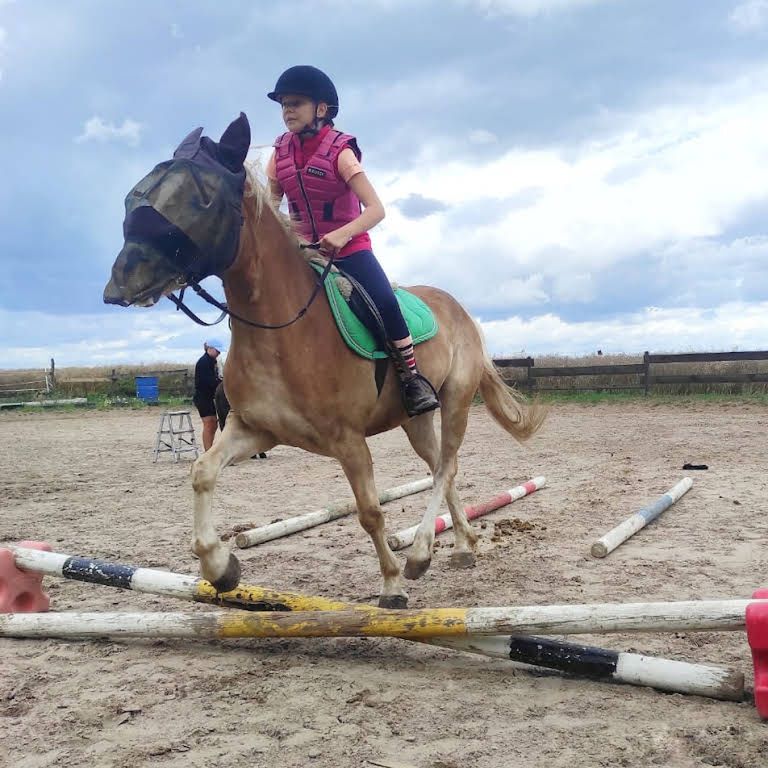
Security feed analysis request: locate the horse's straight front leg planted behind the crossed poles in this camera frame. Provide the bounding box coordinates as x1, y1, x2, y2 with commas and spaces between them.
338, 440, 408, 608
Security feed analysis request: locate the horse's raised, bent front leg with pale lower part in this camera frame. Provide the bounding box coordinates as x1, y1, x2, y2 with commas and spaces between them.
192, 411, 275, 592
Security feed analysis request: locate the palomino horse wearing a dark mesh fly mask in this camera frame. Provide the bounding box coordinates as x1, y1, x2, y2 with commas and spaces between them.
104, 114, 544, 607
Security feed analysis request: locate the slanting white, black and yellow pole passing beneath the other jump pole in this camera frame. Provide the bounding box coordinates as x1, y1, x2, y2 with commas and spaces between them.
10, 547, 744, 701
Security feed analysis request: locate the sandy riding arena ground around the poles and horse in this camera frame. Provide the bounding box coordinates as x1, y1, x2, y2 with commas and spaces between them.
0, 402, 768, 768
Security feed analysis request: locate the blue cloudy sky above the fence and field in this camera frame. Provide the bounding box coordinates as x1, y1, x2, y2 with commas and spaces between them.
0, 0, 768, 368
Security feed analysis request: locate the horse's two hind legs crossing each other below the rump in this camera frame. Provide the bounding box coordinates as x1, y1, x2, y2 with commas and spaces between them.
404, 400, 477, 579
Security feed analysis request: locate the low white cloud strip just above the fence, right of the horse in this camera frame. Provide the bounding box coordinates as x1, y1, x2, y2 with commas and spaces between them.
481, 302, 768, 356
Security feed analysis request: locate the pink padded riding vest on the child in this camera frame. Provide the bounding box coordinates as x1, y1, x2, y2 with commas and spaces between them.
275, 129, 362, 243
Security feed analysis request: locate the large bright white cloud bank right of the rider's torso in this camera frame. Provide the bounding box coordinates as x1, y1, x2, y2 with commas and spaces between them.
370, 68, 768, 311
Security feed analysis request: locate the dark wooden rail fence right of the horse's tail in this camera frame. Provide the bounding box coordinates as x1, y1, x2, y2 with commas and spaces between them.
493, 351, 768, 394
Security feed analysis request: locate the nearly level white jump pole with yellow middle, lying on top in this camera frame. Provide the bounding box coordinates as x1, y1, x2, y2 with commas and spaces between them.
0, 600, 767, 640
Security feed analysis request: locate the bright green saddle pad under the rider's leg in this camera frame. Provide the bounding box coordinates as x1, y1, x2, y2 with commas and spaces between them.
310, 263, 437, 360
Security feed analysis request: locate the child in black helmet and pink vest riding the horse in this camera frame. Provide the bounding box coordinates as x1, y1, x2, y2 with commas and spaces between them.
267, 66, 440, 416
